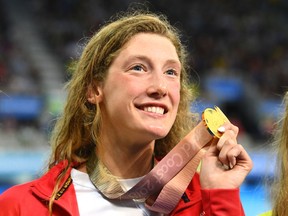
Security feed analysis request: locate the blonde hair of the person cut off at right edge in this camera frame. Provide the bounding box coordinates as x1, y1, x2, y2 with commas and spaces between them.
272, 91, 288, 216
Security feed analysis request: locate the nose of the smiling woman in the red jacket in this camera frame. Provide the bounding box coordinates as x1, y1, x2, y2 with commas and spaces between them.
147, 75, 168, 99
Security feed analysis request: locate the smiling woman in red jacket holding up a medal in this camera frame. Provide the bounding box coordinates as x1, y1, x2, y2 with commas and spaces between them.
0, 11, 252, 216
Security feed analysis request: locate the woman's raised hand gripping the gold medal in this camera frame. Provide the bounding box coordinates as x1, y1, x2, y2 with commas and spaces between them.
200, 122, 253, 189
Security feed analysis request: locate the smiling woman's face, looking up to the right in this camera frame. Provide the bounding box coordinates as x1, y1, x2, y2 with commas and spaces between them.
99, 33, 181, 145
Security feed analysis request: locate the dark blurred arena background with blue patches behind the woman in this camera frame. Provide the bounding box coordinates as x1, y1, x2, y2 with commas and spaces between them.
0, 0, 288, 216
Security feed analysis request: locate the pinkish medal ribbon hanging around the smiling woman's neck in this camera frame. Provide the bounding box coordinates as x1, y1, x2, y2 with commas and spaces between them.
87, 105, 228, 214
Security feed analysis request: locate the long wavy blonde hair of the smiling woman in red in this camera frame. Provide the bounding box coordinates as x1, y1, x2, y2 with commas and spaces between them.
48, 10, 195, 213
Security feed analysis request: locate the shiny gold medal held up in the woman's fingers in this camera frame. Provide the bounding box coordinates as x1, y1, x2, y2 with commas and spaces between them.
202, 106, 229, 138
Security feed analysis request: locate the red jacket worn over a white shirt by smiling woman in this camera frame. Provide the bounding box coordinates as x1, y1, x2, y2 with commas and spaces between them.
0, 162, 245, 216
